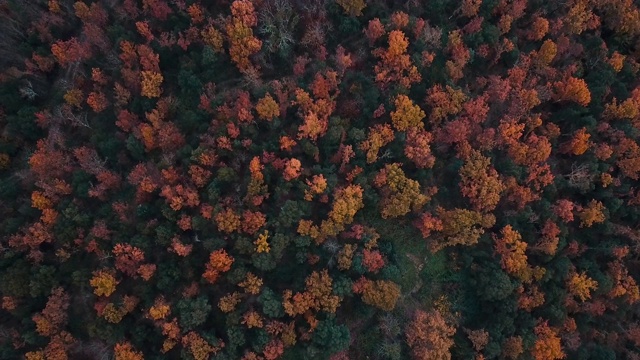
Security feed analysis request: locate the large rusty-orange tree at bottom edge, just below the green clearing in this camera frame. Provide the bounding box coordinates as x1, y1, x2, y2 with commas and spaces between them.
405, 310, 456, 360
